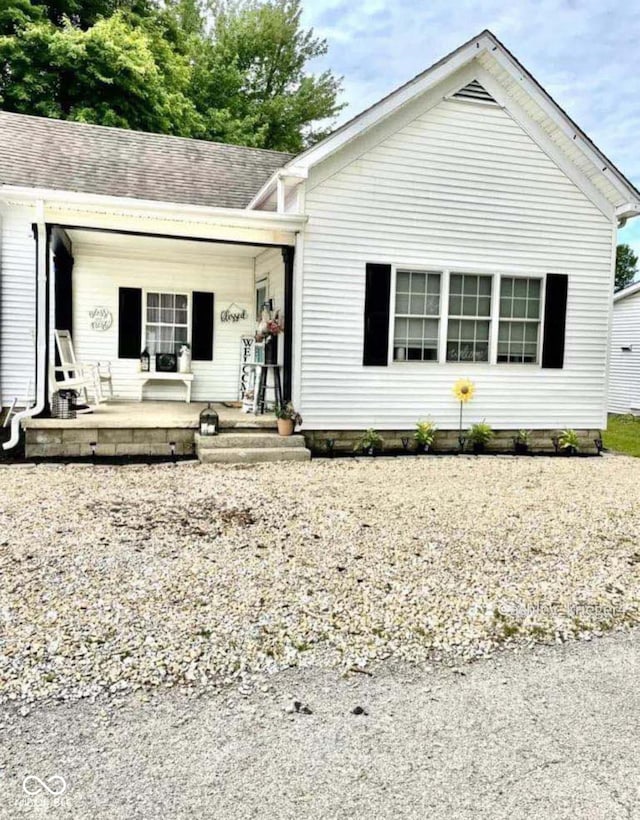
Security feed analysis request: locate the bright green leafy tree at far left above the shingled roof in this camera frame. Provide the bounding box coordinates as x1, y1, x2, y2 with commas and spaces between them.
0, 12, 203, 136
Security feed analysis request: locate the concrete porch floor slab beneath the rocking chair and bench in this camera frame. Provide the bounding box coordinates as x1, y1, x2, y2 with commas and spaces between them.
22, 401, 276, 430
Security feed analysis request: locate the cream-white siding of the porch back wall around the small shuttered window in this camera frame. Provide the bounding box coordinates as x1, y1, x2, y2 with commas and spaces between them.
73, 243, 255, 401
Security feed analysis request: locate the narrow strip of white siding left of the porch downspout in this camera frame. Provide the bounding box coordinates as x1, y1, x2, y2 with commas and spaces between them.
0, 208, 36, 406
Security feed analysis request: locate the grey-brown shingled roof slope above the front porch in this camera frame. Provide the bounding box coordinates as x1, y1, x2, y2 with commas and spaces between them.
0, 111, 292, 208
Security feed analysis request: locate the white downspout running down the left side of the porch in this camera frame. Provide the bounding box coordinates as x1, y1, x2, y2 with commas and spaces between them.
2, 200, 49, 450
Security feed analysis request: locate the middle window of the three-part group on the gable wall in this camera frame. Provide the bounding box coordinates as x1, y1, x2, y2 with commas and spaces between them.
447, 273, 493, 362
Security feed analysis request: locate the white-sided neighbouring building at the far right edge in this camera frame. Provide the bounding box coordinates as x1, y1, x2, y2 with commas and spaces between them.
609, 293, 640, 413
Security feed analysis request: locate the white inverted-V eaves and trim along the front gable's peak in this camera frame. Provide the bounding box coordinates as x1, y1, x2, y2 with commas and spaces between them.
249, 29, 640, 218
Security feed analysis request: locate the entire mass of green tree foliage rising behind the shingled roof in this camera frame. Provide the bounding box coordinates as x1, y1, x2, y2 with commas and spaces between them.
0, 0, 341, 152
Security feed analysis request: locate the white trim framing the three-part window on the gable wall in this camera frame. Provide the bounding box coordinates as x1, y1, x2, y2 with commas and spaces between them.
387, 268, 547, 372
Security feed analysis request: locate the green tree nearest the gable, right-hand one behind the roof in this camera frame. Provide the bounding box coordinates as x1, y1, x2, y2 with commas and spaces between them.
198, 0, 343, 152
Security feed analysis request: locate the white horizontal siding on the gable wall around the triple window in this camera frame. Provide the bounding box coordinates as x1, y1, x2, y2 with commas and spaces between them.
300, 101, 614, 429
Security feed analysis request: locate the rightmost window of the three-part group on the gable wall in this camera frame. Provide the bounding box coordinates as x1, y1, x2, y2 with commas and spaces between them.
498, 276, 542, 364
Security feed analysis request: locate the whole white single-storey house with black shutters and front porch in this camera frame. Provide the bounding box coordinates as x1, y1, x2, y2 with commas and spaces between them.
0, 31, 640, 454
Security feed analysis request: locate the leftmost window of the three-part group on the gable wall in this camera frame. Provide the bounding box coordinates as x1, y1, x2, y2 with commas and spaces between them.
393, 270, 440, 362
